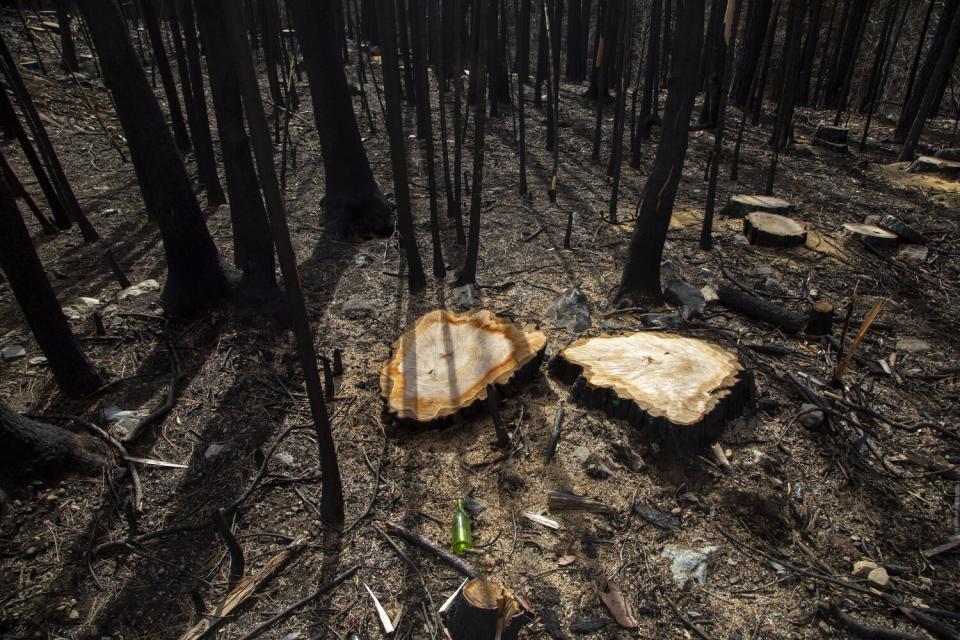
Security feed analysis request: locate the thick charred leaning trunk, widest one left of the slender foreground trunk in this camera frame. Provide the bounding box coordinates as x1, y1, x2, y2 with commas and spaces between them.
77, 0, 230, 315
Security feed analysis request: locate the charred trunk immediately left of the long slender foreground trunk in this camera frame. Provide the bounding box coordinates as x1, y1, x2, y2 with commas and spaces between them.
196, 0, 277, 299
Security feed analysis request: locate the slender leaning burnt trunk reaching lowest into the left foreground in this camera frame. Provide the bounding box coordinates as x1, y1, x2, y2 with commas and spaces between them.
221, 2, 343, 526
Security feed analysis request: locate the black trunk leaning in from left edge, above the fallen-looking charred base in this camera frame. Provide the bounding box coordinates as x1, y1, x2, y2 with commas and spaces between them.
0, 172, 103, 396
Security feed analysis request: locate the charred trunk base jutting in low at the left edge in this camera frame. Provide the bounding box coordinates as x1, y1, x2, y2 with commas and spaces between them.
0, 400, 104, 476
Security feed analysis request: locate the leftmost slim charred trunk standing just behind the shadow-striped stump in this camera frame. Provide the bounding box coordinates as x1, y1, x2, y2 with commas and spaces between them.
377, 0, 427, 291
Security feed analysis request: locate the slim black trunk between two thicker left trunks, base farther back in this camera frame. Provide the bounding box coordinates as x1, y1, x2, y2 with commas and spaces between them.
174, 0, 227, 207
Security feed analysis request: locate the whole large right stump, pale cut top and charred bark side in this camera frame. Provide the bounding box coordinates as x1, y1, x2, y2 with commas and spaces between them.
551, 332, 755, 451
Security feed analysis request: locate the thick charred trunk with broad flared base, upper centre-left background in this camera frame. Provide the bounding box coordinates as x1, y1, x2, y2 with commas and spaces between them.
288, 0, 393, 235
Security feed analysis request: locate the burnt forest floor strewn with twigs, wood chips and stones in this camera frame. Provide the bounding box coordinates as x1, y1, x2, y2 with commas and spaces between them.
0, 15, 960, 640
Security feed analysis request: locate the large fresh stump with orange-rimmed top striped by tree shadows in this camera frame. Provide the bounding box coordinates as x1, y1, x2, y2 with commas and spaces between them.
380, 309, 547, 423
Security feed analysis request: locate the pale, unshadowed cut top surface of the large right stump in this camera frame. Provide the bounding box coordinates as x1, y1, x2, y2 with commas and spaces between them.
560, 333, 743, 427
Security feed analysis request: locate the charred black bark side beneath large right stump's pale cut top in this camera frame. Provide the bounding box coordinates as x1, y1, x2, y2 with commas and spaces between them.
549, 354, 757, 452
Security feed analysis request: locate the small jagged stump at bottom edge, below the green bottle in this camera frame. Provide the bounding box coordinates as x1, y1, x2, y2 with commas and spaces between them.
446, 578, 533, 640
